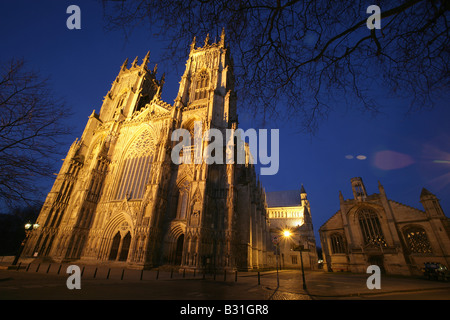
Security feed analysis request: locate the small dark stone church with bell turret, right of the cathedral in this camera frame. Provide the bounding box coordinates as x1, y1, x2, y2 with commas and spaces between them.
319, 178, 450, 275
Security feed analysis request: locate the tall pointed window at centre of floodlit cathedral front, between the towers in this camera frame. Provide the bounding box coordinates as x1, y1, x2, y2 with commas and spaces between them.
115, 130, 155, 200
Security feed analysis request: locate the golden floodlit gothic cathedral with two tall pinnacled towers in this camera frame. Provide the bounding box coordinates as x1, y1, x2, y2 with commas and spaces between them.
23, 32, 271, 270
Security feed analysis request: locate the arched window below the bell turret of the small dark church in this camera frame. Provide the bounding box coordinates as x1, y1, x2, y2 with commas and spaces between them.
357, 208, 386, 247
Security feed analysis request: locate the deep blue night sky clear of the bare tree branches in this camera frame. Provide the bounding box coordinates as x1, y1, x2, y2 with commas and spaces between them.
0, 0, 450, 245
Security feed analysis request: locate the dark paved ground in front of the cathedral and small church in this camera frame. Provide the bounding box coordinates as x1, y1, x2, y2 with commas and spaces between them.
0, 263, 450, 301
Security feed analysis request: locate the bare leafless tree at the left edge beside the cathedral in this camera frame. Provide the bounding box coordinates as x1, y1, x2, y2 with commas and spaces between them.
0, 60, 70, 207
